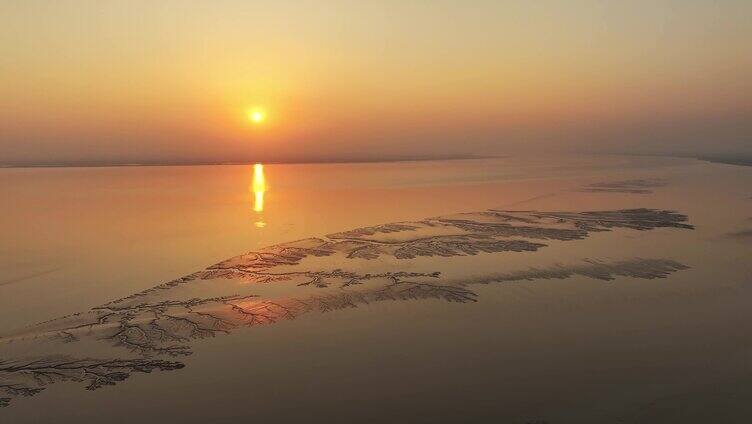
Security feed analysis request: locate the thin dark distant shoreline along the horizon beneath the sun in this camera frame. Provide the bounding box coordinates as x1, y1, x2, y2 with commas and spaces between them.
0, 155, 494, 169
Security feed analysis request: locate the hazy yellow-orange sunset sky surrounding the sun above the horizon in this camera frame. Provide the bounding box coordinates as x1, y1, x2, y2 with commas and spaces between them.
0, 0, 752, 163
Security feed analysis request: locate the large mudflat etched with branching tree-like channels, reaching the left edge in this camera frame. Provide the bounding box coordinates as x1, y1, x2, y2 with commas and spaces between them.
0, 209, 692, 406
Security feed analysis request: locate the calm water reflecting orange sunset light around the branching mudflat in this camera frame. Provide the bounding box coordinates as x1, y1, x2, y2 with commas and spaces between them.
0, 156, 752, 423
